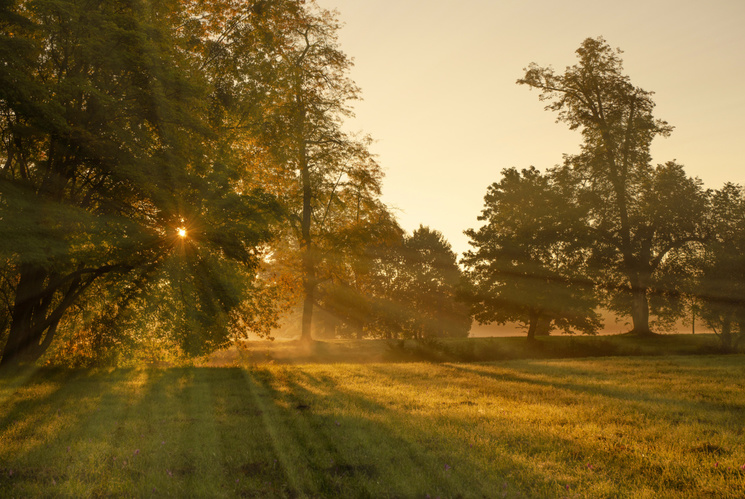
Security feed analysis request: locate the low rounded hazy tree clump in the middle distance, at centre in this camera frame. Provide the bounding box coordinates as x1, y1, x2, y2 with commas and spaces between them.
304, 226, 471, 339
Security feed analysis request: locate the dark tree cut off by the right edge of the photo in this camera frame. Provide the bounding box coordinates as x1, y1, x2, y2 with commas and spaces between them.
697, 183, 745, 351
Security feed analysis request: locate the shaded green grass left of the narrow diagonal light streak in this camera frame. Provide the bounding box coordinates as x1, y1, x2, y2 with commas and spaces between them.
0, 368, 296, 497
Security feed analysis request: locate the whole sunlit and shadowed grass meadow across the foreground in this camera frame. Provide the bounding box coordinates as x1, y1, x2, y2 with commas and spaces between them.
0, 355, 745, 498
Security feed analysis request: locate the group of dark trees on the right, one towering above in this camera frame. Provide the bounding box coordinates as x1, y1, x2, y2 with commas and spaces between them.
463, 38, 745, 349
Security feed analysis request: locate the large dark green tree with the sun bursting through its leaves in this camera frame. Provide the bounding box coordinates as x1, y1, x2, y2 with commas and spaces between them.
0, 0, 278, 364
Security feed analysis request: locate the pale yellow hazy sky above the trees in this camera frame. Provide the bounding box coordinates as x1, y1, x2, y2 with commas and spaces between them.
317, 0, 745, 253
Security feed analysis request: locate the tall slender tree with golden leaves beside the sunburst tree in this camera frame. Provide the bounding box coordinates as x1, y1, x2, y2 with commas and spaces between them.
225, 1, 386, 341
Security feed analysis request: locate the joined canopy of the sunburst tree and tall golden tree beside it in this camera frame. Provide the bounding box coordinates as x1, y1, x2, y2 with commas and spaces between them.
0, 0, 400, 363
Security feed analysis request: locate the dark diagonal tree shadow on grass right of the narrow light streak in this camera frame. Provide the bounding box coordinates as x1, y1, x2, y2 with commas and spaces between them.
253, 366, 608, 497
